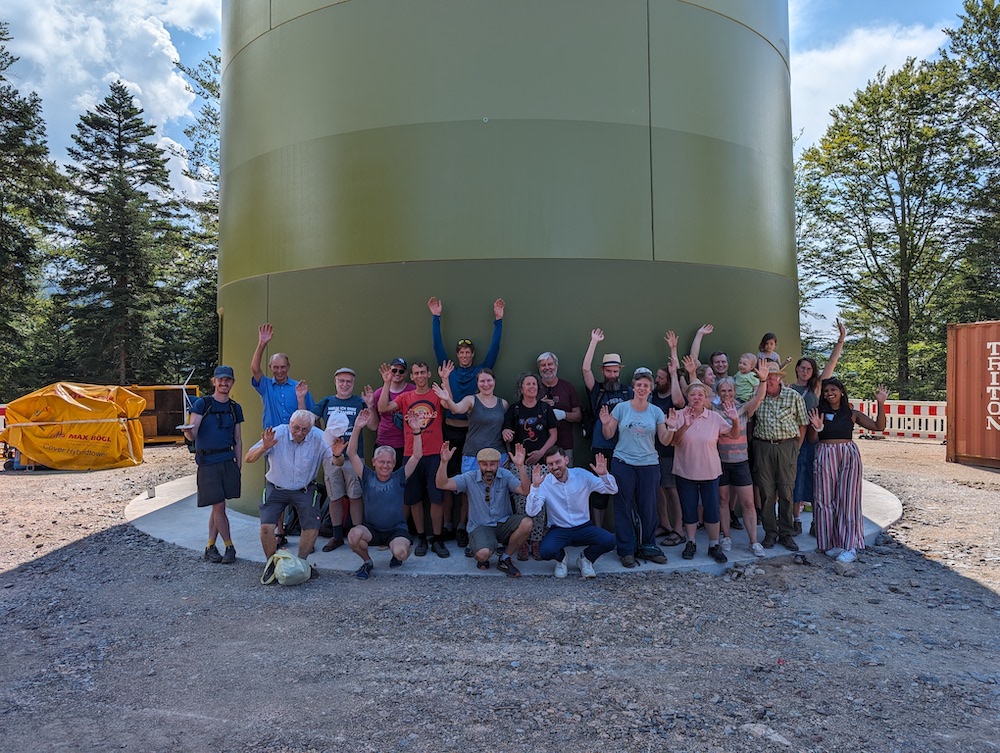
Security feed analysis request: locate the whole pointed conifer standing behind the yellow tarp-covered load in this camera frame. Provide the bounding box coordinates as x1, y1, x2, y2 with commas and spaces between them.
60, 82, 178, 384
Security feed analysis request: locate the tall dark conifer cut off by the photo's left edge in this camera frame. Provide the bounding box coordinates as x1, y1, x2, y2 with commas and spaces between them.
0, 22, 64, 402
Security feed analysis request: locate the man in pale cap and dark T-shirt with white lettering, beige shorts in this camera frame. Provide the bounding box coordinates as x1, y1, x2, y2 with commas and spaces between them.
313, 366, 375, 552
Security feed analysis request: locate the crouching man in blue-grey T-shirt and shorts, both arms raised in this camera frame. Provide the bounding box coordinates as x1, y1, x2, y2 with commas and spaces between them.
347, 408, 424, 580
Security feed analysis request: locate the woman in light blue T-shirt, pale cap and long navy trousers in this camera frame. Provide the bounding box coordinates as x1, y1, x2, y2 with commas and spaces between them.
599, 366, 674, 567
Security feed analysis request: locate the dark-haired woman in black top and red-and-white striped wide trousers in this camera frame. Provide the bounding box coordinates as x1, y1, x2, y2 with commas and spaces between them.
809, 379, 889, 562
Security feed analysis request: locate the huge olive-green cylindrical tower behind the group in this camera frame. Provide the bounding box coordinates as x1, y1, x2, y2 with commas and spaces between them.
219, 0, 798, 510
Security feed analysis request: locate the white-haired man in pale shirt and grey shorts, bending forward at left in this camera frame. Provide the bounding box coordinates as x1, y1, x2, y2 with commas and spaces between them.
244, 410, 344, 559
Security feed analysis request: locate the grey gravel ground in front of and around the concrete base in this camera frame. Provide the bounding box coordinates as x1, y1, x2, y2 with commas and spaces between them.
0, 440, 1000, 753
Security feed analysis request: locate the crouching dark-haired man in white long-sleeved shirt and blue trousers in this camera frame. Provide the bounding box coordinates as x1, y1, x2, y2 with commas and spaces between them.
526, 445, 618, 578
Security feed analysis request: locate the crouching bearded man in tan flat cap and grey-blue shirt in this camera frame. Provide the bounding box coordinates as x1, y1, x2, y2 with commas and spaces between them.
437, 442, 531, 578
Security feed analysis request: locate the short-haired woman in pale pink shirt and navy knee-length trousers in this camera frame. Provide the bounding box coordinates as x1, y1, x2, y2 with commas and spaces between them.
667, 383, 740, 563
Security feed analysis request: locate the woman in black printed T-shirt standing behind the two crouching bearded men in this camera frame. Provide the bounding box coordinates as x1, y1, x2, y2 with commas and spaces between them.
503, 372, 558, 561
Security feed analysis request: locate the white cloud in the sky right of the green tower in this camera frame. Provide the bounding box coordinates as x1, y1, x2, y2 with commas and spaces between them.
791, 22, 945, 150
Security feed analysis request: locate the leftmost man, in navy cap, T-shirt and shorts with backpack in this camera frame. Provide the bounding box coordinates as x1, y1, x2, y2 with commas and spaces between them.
184, 366, 243, 565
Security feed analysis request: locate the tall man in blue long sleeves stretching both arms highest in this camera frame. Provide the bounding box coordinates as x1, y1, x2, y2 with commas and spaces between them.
427, 297, 506, 547
